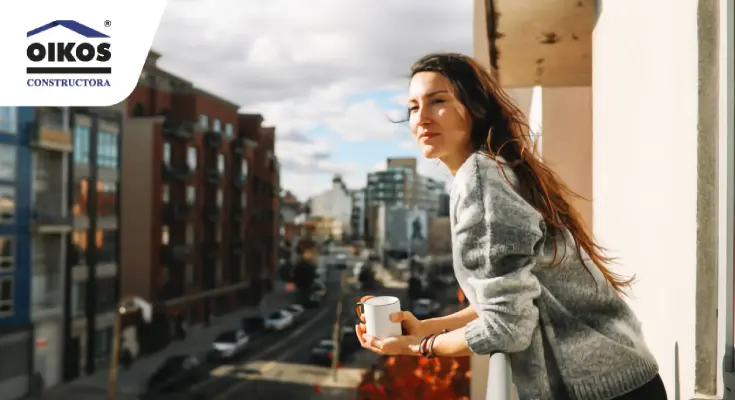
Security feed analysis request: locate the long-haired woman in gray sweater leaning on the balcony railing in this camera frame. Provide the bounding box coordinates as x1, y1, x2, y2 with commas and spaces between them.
356, 54, 666, 400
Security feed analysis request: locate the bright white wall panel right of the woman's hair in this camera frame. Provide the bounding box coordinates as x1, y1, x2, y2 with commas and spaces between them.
592, 0, 698, 399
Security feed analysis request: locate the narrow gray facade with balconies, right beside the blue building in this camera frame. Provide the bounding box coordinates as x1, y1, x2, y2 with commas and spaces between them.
28, 107, 74, 387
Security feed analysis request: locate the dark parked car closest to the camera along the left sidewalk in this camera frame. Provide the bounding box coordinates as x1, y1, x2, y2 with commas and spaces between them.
141, 354, 208, 399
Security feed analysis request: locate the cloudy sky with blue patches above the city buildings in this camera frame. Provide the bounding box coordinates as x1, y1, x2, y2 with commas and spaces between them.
153, 0, 472, 200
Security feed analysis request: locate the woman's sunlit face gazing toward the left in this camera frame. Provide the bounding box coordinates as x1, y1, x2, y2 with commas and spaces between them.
408, 72, 472, 167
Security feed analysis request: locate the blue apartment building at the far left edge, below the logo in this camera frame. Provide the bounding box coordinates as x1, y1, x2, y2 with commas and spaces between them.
0, 107, 34, 400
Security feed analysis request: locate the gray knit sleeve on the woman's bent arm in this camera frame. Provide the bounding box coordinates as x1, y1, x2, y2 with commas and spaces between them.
454, 158, 545, 354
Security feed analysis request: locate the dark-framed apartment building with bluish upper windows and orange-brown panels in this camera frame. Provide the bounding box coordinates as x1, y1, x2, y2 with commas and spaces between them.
63, 106, 125, 381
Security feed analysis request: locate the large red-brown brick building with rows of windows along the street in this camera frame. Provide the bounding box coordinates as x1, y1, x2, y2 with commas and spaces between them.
121, 52, 278, 334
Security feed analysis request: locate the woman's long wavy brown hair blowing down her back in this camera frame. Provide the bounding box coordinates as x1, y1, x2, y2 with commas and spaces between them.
411, 53, 633, 293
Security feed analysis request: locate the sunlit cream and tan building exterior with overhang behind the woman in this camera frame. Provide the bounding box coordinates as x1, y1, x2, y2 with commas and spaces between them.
472, 0, 735, 399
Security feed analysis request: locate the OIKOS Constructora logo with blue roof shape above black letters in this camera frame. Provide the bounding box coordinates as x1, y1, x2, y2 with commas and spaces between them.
26, 20, 112, 87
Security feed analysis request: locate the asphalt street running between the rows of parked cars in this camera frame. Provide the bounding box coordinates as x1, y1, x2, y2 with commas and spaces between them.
190, 258, 403, 400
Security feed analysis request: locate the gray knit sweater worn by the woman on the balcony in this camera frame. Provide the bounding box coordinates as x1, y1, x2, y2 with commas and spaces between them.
450, 153, 658, 400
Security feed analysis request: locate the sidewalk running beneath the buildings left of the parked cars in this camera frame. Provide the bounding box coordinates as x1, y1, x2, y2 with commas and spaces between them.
40, 284, 300, 400
